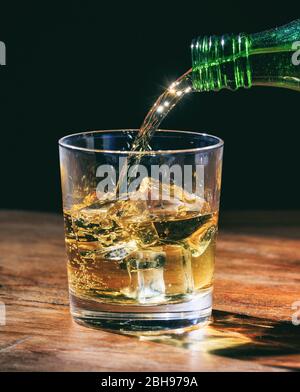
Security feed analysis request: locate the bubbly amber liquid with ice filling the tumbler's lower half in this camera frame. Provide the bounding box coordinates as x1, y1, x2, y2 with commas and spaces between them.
64, 179, 218, 305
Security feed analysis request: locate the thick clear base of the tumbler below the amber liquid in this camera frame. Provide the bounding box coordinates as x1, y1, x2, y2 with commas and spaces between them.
70, 289, 212, 334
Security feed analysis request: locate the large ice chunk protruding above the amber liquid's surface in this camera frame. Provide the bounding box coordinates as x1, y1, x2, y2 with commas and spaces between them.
108, 177, 208, 247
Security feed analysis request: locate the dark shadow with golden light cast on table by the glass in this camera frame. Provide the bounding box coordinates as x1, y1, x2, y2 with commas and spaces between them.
139, 311, 300, 370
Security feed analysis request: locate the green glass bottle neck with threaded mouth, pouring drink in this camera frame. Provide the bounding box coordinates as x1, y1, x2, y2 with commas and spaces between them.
191, 19, 300, 91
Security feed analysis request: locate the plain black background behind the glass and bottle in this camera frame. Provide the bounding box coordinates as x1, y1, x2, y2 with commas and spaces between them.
0, 0, 300, 211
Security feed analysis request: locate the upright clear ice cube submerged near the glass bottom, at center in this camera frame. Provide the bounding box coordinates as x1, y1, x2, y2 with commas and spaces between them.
121, 249, 166, 304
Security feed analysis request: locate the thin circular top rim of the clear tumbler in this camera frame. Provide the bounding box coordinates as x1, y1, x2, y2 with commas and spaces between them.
58, 128, 224, 155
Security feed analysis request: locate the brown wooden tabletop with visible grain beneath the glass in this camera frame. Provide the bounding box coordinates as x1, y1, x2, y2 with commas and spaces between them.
0, 211, 300, 372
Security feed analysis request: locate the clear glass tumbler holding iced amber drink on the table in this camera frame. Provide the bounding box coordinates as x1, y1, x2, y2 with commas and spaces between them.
59, 130, 223, 333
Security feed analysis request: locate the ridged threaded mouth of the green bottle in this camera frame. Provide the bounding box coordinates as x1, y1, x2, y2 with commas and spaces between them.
191, 33, 252, 91
